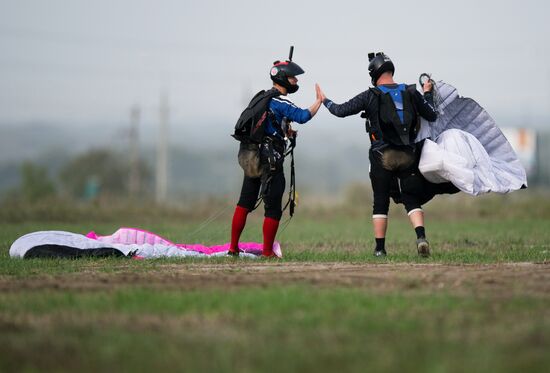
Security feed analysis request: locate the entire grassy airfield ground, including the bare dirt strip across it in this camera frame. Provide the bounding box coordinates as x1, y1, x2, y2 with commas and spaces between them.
0, 192, 550, 372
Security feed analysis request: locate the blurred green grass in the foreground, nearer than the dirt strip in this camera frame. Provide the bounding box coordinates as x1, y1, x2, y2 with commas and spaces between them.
0, 285, 550, 372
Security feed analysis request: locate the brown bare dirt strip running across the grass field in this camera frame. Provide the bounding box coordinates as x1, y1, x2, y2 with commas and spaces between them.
0, 262, 550, 297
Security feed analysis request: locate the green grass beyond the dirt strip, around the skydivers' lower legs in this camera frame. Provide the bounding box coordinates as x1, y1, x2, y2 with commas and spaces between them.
0, 214, 550, 275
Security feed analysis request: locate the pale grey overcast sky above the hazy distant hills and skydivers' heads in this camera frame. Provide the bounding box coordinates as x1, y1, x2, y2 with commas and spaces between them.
0, 0, 550, 133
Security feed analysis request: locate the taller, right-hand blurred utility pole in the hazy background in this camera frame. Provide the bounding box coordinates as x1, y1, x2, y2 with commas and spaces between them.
155, 92, 170, 204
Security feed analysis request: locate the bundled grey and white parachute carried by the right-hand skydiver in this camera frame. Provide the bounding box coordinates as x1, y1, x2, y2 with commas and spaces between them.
416, 81, 527, 195
